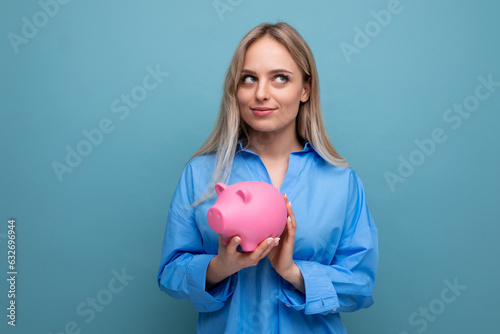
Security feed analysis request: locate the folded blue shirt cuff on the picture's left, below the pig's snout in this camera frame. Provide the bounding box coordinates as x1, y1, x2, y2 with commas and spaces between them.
186, 254, 235, 312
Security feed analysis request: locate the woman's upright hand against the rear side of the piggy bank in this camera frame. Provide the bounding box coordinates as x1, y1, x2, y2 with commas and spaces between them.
267, 194, 305, 293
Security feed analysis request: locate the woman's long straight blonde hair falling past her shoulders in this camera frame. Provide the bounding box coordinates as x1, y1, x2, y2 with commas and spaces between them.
191, 22, 349, 206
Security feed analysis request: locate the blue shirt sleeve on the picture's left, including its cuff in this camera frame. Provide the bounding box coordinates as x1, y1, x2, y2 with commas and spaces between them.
158, 165, 236, 312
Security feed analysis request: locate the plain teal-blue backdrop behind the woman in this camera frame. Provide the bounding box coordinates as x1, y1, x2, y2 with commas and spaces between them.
0, 0, 500, 334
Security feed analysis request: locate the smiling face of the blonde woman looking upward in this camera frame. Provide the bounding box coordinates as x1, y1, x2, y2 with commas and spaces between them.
237, 36, 310, 137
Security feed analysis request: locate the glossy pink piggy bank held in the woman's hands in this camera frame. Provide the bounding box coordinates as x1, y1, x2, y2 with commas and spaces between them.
207, 181, 287, 252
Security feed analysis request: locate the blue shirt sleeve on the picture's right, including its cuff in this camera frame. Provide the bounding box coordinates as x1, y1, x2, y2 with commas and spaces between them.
278, 171, 378, 314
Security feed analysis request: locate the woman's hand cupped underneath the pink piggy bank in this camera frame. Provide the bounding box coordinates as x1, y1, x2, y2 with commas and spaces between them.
205, 234, 279, 290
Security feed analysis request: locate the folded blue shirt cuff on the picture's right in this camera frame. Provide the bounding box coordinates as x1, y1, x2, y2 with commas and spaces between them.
278, 260, 340, 314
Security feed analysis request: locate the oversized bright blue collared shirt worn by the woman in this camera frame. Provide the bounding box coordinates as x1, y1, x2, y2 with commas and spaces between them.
158, 143, 378, 334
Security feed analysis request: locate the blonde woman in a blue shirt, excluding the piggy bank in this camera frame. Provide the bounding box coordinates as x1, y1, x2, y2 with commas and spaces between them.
158, 22, 378, 334
